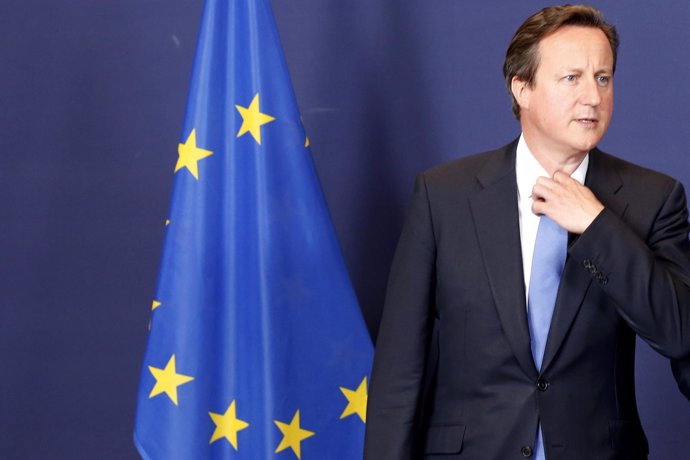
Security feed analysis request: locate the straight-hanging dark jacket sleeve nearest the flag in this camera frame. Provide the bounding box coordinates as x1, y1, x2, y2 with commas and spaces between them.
364, 175, 436, 460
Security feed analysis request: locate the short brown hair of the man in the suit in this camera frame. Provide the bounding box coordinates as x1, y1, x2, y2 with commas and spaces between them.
503, 5, 618, 120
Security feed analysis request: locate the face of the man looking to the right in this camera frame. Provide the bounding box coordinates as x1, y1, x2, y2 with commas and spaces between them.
520, 26, 613, 156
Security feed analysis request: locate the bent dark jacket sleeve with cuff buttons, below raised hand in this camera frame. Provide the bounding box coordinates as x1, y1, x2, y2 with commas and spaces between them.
569, 181, 690, 358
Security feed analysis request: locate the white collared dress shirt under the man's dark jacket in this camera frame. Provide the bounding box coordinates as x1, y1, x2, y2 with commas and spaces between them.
515, 135, 589, 300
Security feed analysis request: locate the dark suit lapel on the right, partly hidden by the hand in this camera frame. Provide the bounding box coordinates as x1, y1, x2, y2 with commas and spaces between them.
541, 149, 627, 372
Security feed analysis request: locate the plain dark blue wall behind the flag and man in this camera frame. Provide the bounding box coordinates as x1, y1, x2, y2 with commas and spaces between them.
0, 0, 690, 460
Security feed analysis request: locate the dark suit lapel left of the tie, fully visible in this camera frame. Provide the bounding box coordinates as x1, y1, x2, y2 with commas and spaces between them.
470, 142, 536, 376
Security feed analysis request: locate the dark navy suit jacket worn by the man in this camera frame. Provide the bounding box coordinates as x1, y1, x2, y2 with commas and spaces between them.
365, 142, 690, 460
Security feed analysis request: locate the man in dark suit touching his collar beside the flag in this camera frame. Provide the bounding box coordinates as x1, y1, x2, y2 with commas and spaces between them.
365, 6, 690, 460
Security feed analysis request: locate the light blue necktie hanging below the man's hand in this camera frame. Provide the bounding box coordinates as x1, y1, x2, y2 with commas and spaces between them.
527, 216, 568, 460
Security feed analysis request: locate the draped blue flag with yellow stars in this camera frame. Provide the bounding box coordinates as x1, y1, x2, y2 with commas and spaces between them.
134, 0, 373, 460
